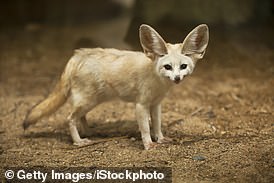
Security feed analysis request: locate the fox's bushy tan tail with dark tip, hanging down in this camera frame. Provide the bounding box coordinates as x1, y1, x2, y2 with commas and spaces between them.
23, 72, 70, 130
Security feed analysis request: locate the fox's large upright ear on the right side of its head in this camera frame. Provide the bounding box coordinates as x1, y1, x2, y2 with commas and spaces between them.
182, 24, 209, 59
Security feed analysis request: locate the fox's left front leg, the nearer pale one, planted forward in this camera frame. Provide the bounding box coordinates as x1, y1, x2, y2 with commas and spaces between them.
136, 103, 156, 150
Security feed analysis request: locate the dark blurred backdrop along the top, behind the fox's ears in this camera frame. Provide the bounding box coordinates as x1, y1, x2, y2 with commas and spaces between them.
0, 0, 274, 48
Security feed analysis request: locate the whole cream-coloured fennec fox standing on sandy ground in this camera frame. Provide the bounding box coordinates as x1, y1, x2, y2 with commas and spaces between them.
23, 24, 209, 149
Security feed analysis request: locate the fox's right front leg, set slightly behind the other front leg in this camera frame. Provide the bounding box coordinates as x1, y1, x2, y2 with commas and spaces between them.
150, 104, 172, 143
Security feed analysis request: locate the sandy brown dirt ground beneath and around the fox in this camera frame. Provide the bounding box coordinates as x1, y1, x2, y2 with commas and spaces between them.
0, 21, 274, 183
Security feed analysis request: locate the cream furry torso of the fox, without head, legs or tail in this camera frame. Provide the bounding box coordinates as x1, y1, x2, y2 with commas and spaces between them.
66, 48, 161, 101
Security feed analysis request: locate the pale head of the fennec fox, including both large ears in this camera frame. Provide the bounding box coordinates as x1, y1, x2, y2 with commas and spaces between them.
140, 24, 209, 84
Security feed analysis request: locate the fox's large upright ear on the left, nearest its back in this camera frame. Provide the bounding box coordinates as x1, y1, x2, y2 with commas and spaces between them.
139, 24, 167, 59
